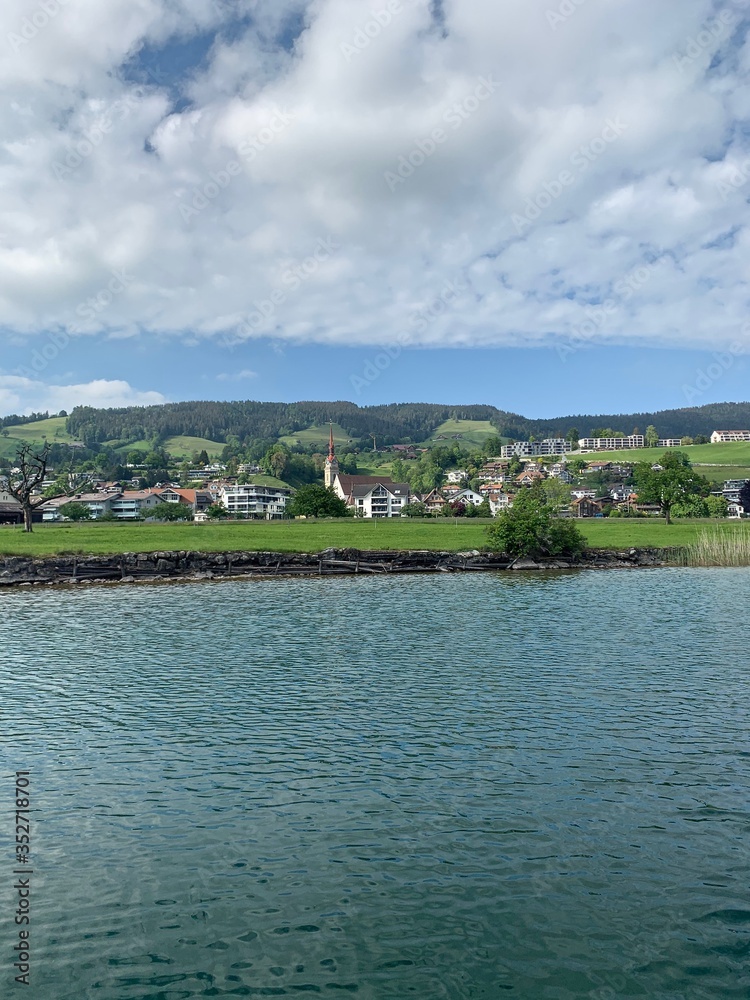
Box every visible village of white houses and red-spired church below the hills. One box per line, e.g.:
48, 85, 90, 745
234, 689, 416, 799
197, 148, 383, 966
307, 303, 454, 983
0, 430, 750, 524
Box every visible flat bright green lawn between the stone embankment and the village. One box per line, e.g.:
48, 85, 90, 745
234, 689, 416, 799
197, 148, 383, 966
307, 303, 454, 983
0, 518, 750, 556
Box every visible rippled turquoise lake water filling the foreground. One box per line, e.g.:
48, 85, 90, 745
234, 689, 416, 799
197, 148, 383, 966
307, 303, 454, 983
0, 569, 750, 1000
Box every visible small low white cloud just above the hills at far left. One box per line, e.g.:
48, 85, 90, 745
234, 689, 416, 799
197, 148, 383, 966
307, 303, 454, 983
0, 375, 167, 414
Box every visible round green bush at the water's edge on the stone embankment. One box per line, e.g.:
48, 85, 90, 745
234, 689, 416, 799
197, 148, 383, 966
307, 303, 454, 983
487, 487, 586, 558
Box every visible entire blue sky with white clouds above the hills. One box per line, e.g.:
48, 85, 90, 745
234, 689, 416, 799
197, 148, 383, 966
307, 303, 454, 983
0, 0, 750, 417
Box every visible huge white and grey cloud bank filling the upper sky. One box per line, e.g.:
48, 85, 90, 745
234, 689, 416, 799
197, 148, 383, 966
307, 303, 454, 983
0, 0, 750, 356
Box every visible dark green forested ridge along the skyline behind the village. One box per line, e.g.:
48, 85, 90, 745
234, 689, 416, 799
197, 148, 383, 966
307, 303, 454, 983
67, 400, 750, 445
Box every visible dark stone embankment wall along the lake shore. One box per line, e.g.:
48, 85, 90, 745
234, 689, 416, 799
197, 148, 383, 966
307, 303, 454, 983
0, 549, 665, 587
